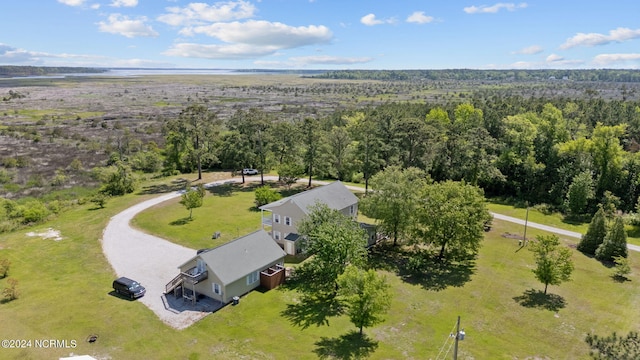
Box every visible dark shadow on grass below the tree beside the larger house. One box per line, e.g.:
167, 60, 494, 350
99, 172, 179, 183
282, 296, 342, 329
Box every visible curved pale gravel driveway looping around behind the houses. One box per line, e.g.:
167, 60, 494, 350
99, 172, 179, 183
102, 176, 640, 329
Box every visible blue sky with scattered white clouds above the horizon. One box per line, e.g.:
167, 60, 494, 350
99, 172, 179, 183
0, 0, 640, 69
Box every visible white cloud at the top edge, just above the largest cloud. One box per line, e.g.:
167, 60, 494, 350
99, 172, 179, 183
157, 0, 256, 26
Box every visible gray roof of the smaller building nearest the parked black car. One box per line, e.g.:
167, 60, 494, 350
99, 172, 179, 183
198, 230, 286, 285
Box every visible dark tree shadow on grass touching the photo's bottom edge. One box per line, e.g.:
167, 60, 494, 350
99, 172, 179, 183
313, 331, 378, 359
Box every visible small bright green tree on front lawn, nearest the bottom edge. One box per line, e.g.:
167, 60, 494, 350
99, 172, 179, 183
338, 265, 391, 335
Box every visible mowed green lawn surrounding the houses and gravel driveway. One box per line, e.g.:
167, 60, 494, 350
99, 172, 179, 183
0, 173, 640, 359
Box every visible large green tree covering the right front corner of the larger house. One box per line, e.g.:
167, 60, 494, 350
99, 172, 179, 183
293, 203, 367, 297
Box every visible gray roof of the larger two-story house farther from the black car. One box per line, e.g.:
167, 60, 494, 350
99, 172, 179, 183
260, 181, 358, 215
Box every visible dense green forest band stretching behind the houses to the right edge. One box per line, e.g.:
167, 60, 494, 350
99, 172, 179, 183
165, 93, 640, 215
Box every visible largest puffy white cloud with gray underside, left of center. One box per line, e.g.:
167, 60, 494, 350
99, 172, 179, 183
188, 20, 333, 49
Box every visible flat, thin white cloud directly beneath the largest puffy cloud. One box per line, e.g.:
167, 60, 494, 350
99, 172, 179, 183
163, 43, 278, 60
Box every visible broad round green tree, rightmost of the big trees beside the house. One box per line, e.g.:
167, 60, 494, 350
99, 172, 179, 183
413, 181, 491, 260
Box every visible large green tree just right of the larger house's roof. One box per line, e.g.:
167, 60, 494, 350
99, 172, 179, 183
360, 166, 426, 246
